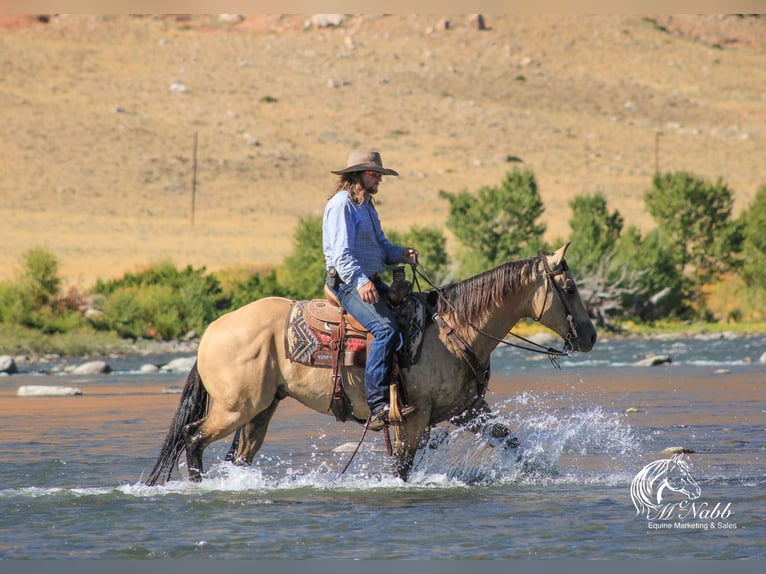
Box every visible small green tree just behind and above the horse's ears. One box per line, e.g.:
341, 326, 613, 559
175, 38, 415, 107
567, 192, 623, 276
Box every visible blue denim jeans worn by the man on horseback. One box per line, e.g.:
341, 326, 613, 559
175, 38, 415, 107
335, 279, 399, 413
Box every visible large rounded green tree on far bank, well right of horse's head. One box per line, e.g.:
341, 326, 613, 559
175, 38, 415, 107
644, 172, 742, 289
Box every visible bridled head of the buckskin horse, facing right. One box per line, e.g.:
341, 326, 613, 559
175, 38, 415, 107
533, 243, 597, 352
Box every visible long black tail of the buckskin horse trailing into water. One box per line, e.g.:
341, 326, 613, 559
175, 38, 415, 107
144, 361, 207, 486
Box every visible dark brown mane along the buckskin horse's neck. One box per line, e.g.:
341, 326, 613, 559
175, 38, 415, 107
436, 256, 540, 324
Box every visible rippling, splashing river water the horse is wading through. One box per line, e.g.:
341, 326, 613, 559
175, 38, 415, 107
0, 337, 766, 559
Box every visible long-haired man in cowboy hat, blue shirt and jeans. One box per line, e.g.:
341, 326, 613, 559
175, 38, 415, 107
322, 150, 418, 429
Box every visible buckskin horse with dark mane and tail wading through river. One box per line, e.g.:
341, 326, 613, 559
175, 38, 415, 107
145, 243, 597, 485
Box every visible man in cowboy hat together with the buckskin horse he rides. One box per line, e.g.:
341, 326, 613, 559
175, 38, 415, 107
146, 146, 597, 485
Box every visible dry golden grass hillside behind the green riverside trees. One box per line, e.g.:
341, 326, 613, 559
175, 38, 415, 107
0, 15, 766, 285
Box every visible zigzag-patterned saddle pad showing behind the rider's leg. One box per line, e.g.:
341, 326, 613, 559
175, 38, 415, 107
285, 301, 367, 368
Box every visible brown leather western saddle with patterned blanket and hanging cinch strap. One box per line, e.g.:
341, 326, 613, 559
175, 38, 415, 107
285, 287, 426, 422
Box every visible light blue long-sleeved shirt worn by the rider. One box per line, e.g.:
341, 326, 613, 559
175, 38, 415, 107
322, 189, 404, 288
